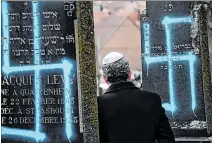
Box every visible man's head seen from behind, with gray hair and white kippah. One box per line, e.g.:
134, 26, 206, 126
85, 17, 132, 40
102, 52, 131, 84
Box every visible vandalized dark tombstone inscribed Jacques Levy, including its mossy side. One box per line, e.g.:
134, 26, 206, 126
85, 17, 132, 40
1, 1, 99, 143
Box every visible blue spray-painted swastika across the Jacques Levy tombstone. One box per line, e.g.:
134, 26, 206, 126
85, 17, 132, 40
2, 1, 74, 142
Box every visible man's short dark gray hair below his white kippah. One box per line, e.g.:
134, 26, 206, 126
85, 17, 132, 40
102, 57, 130, 84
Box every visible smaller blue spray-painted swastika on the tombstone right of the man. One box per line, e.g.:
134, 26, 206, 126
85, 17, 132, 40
143, 16, 196, 114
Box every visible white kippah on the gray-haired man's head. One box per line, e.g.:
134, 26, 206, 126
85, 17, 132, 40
102, 52, 124, 65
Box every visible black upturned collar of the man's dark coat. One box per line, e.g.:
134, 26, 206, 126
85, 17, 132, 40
105, 81, 138, 93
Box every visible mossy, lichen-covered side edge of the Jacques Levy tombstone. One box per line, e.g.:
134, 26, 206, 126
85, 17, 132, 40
77, 1, 99, 143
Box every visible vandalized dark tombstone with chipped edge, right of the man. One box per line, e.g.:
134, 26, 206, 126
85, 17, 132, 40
141, 1, 212, 137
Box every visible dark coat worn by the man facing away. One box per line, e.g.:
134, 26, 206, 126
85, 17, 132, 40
98, 82, 175, 143
